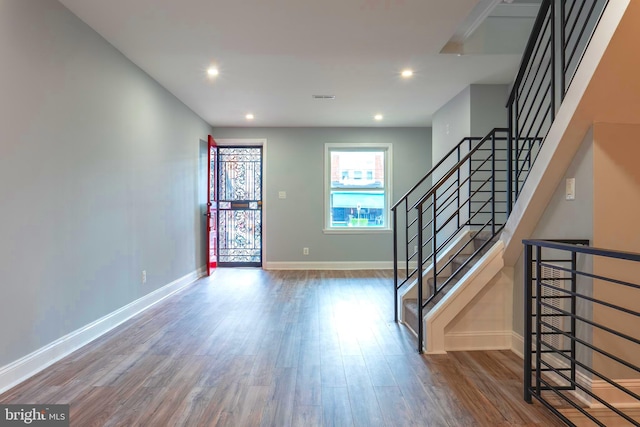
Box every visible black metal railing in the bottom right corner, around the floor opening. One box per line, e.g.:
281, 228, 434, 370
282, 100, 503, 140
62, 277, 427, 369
523, 240, 640, 426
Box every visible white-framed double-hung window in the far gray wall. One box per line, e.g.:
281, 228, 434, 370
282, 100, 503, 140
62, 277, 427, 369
325, 144, 391, 233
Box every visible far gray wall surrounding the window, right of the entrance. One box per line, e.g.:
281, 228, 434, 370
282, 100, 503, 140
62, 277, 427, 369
214, 128, 431, 263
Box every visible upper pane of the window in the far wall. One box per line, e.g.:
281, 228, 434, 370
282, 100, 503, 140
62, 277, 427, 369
331, 150, 384, 188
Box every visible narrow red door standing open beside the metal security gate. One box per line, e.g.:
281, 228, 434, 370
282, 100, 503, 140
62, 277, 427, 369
207, 135, 218, 276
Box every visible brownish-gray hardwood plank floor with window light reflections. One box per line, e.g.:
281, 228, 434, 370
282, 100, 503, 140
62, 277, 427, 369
0, 269, 562, 427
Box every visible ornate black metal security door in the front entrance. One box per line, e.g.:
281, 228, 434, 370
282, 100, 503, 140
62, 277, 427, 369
218, 146, 262, 267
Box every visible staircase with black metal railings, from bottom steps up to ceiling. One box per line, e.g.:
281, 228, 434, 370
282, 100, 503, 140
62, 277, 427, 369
392, 0, 607, 352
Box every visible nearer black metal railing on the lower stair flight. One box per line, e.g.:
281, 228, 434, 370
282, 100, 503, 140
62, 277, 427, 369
412, 129, 508, 352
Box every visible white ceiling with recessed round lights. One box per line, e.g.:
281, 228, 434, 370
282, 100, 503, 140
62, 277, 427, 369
60, 0, 528, 127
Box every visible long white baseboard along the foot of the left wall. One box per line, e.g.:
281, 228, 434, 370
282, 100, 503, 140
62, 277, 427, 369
0, 268, 206, 393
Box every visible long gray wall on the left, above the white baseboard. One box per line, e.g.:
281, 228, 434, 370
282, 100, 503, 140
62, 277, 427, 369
0, 0, 210, 366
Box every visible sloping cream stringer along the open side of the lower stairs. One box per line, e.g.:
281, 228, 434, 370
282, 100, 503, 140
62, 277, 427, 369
423, 241, 504, 354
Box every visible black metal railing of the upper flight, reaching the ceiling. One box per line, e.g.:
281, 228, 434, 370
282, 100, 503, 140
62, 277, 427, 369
507, 0, 608, 211
